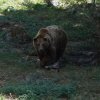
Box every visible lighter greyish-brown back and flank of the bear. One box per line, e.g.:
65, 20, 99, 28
46, 25, 67, 60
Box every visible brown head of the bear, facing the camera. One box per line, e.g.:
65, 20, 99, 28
33, 28, 51, 55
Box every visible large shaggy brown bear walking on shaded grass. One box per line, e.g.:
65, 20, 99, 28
33, 25, 67, 68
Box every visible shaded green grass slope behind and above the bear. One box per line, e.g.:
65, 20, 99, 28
0, 0, 95, 41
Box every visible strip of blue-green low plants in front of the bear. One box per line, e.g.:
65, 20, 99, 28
0, 80, 76, 100
